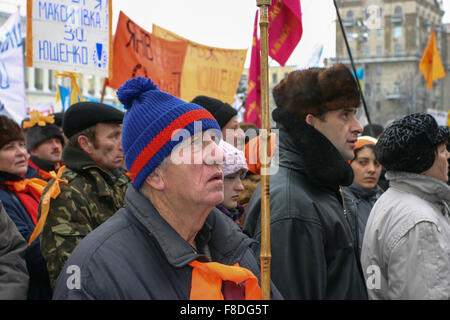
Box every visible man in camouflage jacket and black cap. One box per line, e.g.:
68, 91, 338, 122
40, 102, 129, 287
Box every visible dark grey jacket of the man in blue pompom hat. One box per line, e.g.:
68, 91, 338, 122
53, 185, 280, 300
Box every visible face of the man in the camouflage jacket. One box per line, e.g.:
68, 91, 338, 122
90, 123, 123, 170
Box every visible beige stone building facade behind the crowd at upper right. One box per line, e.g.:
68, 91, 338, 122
333, 0, 450, 125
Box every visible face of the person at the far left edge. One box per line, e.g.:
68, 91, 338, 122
0, 140, 30, 177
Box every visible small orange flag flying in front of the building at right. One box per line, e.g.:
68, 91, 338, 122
419, 30, 445, 90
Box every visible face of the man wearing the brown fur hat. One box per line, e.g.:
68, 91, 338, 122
313, 108, 363, 160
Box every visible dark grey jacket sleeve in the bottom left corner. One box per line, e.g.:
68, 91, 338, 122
0, 201, 29, 300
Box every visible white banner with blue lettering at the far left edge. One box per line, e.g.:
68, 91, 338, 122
0, 11, 27, 124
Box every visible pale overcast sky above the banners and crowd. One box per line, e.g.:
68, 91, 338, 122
0, 0, 450, 67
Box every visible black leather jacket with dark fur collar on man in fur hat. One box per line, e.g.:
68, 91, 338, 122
244, 108, 367, 299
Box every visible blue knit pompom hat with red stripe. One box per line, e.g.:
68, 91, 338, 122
117, 77, 220, 189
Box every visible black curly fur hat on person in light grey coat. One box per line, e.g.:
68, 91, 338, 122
375, 113, 449, 174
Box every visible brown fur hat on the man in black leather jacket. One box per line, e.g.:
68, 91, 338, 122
272, 64, 361, 119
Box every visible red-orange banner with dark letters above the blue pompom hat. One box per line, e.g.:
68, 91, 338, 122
106, 11, 188, 97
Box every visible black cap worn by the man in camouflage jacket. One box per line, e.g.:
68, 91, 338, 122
63, 101, 124, 138
